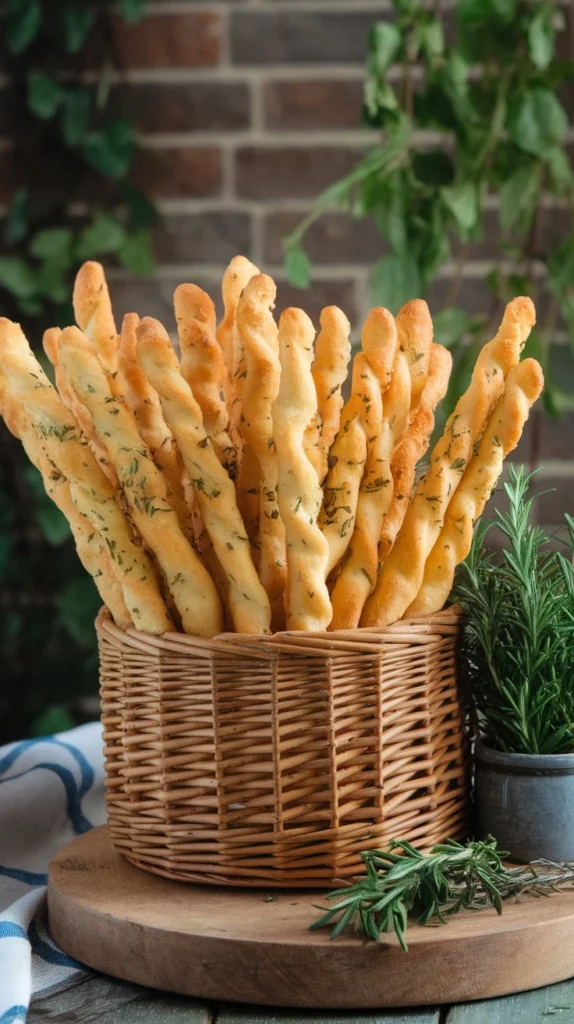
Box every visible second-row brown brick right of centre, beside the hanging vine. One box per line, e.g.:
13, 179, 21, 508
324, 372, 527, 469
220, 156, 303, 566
264, 79, 362, 131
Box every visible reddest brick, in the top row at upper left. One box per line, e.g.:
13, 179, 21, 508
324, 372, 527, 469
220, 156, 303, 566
116, 11, 221, 68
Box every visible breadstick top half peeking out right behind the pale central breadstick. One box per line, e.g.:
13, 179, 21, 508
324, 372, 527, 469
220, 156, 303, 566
305, 306, 351, 483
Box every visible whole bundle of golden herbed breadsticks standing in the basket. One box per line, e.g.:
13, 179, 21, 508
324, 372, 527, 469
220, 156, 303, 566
0, 256, 543, 637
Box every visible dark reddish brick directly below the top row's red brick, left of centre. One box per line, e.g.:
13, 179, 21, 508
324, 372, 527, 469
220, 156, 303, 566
127, 82, 250, 132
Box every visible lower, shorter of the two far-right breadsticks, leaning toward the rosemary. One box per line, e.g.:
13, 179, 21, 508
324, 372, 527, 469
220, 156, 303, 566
406, 359, 544, 617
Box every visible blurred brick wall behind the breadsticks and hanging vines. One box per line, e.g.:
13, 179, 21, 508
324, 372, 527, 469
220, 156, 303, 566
107, 0, 574, 522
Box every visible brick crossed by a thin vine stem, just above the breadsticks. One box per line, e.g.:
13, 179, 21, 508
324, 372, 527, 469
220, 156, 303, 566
264, 210, 389, 264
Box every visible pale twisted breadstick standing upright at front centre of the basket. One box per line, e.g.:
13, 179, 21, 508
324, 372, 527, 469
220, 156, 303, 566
272, 309, 332, 630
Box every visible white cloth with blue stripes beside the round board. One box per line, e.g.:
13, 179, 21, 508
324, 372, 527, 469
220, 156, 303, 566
0, 723, 105, 1024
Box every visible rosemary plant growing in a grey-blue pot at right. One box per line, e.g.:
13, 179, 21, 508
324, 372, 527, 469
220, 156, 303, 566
453, 467, 574, 861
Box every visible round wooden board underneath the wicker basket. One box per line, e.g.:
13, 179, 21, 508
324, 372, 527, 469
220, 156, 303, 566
48, 827, 574, 1010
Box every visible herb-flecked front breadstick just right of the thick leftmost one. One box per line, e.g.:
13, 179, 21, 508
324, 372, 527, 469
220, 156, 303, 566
59, 328, 222, 637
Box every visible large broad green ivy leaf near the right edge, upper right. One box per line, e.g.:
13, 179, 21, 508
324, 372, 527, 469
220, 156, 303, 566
506, 86, 568, 158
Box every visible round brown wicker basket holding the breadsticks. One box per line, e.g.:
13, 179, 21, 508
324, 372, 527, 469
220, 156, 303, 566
97, 609, 468, 888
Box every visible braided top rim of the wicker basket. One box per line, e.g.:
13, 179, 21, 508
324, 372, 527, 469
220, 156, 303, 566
96, 604, 462, 657
